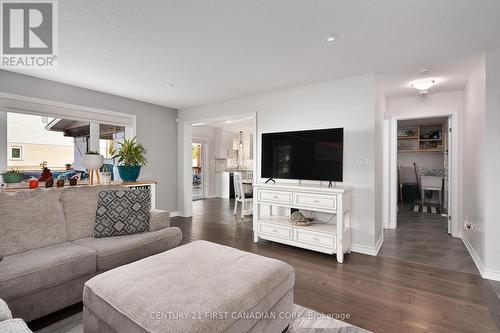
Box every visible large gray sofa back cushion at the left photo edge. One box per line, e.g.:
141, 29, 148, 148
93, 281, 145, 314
0, 189, 67, 255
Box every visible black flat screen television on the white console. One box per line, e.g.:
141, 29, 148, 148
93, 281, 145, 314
261, 128, 344, 182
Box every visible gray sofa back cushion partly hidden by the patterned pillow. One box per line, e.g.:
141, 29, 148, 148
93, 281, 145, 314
61, 185, 122, 241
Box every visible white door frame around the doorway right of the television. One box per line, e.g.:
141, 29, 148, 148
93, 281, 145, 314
384, 111, 462, 238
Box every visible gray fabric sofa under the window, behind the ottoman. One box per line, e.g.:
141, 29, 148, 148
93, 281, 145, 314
0, 186, 182, 321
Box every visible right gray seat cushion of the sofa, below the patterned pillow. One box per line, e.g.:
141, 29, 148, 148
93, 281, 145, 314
73, 227, 182, 271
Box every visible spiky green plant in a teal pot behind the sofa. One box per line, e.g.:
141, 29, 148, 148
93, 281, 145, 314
113, 138, 147, 182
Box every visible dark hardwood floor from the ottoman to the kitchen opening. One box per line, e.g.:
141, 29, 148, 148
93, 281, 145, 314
172, 199, 498, 333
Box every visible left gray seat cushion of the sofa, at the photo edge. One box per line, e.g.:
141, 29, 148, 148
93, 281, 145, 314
0, 242, 96, 301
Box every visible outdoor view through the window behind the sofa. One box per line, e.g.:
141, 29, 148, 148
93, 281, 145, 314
7, 113, 125, 176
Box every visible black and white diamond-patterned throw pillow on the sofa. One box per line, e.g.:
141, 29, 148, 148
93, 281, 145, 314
94, 189, 151, 238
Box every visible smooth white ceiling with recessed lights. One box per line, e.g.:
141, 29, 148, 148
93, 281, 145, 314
9, 0, 500, 108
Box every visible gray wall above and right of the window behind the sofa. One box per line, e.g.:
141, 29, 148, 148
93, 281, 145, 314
0, 70, 177, 211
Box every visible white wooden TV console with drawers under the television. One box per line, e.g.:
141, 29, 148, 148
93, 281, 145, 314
253, 183, 352, 263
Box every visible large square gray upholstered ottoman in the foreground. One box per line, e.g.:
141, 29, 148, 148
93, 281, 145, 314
83, 241, 295, 333
